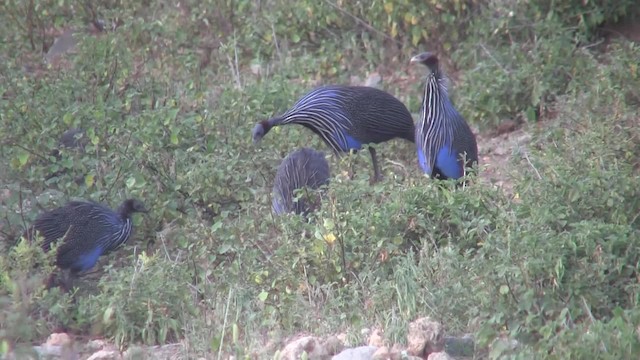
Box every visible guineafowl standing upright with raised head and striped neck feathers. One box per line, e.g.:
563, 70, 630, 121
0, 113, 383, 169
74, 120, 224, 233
411, 52, 478, 179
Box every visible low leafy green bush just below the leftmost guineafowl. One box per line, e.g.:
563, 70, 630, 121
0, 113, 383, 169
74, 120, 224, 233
77, 253, 196, 346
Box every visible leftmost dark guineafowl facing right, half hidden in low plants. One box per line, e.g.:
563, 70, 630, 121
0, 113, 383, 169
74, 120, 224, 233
25, 199, 147, 274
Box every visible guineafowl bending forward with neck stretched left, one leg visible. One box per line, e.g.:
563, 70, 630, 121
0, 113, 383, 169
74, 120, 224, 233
253, 85, 415, 181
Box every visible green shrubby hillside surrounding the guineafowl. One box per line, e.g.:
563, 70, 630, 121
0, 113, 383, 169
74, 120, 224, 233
0, 0, 640, 359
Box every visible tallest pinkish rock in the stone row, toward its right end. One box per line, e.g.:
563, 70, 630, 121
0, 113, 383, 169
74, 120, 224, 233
407, 317, 444, 357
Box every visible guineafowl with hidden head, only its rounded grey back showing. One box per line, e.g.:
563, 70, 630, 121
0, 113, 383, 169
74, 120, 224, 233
272, 148, 330, 215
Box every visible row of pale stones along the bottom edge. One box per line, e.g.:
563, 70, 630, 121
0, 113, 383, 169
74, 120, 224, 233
12, 318, 484, 360
